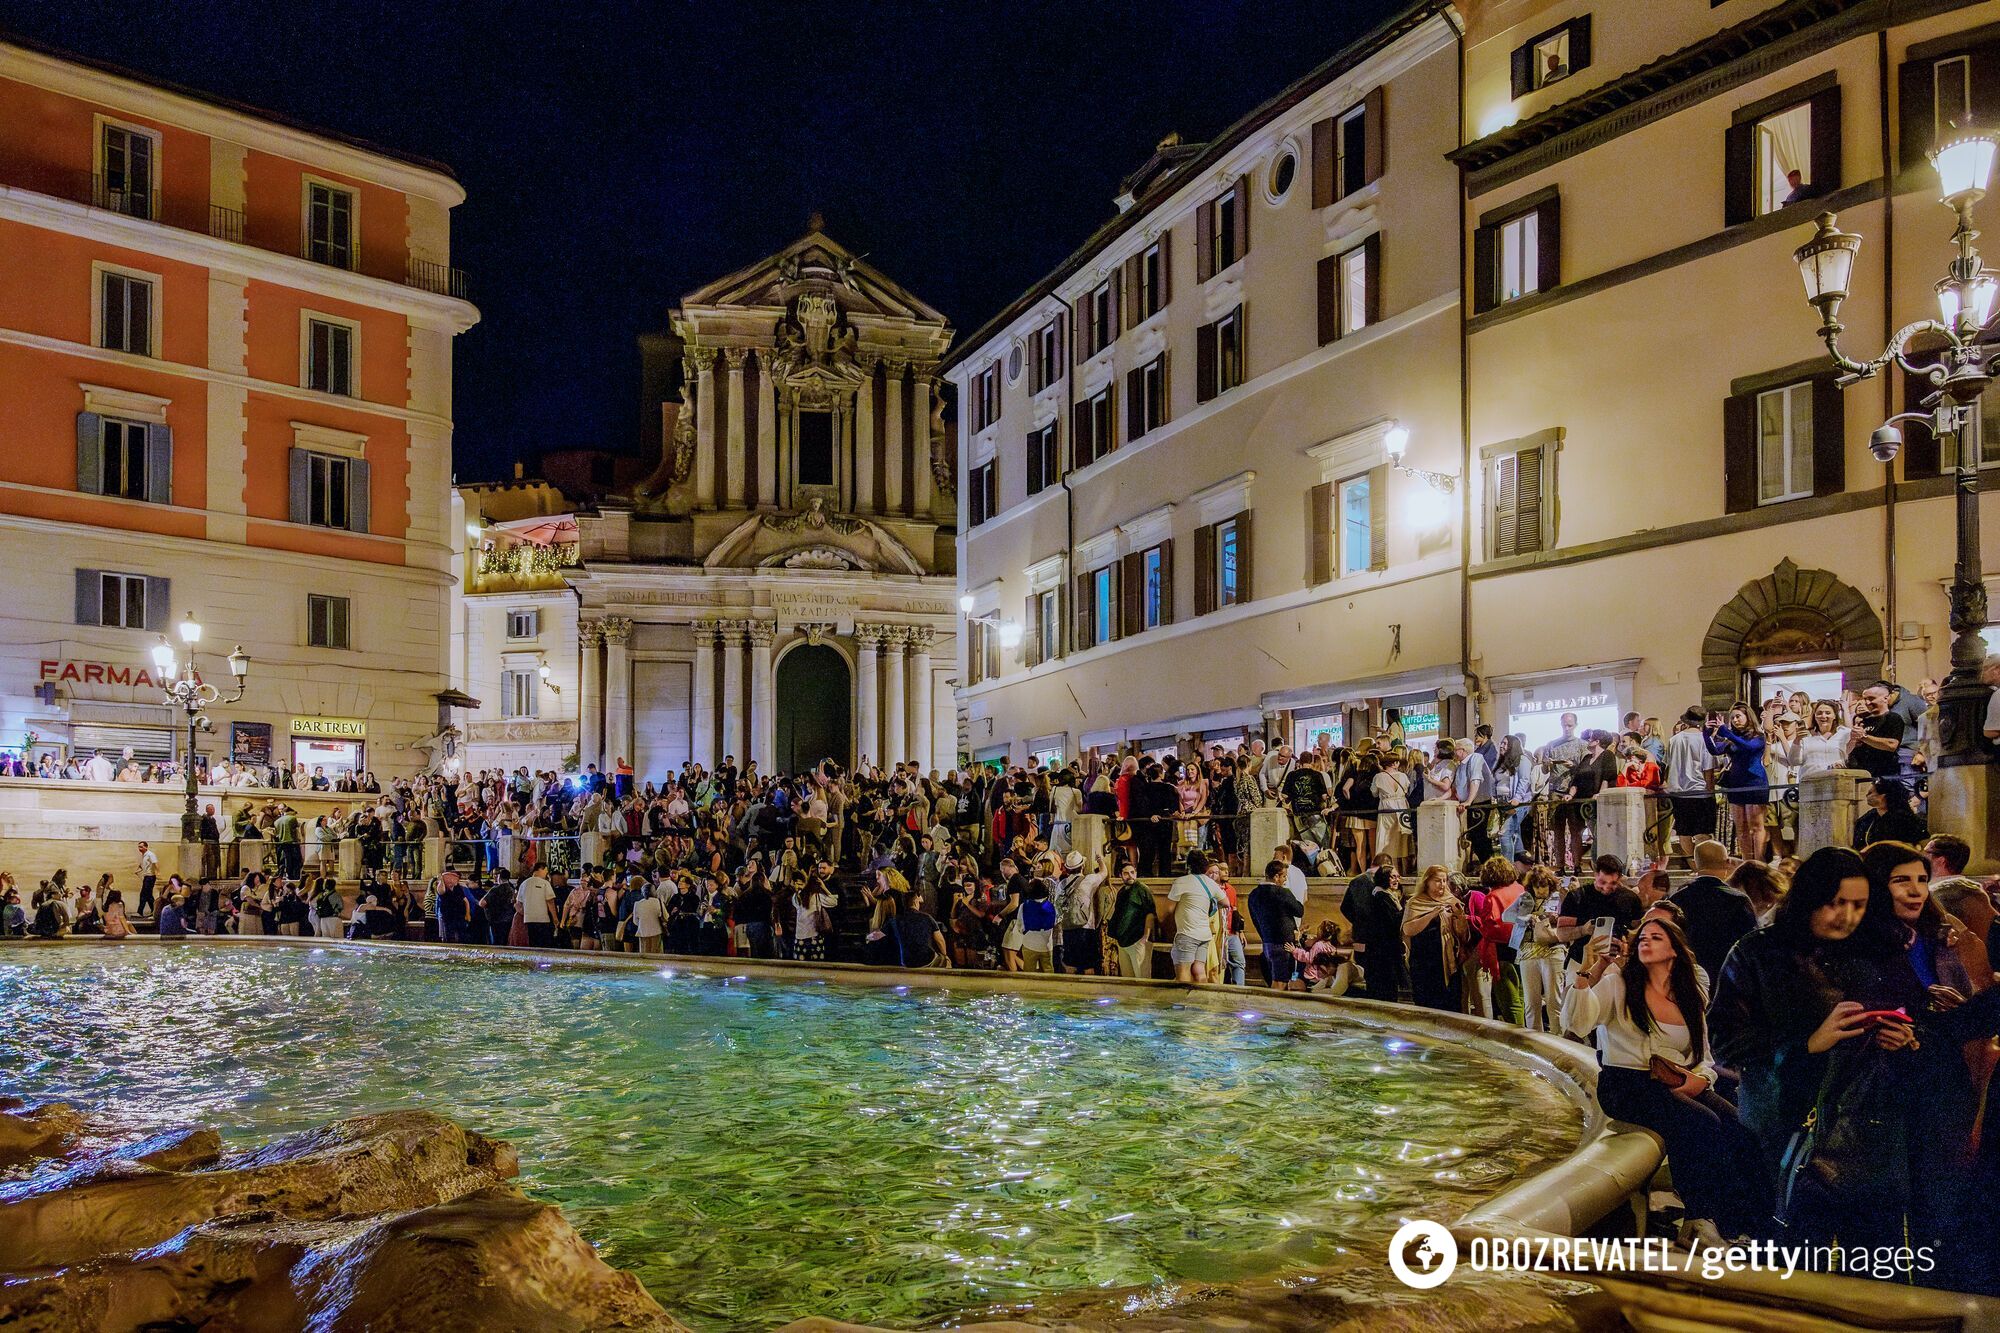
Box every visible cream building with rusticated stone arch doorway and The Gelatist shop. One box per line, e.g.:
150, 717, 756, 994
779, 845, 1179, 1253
1454, 0, 2000, 731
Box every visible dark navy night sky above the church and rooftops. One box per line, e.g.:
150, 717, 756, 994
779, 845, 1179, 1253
0, 0, 1400, 480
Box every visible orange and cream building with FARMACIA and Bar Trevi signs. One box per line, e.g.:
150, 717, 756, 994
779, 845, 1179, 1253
0, 38, 478, 775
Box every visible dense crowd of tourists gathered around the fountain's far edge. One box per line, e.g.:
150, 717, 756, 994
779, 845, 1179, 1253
11, 685, 2000, 1291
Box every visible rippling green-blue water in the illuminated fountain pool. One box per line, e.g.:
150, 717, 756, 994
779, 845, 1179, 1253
0, 945, 1578, 1329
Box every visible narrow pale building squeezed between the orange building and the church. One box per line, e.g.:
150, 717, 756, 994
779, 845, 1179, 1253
452, 480, 582, 773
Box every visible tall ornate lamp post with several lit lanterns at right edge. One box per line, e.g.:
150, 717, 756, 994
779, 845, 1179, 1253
1792, 128, 2000, 772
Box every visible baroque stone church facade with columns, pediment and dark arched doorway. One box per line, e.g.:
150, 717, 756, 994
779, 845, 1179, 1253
566, 224, 958, 781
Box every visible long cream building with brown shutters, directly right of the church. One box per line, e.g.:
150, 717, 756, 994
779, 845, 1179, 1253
948, 6, 1468, 761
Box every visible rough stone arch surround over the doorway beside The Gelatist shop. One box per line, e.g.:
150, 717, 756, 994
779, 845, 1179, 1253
1702, 558, 1886, 709
